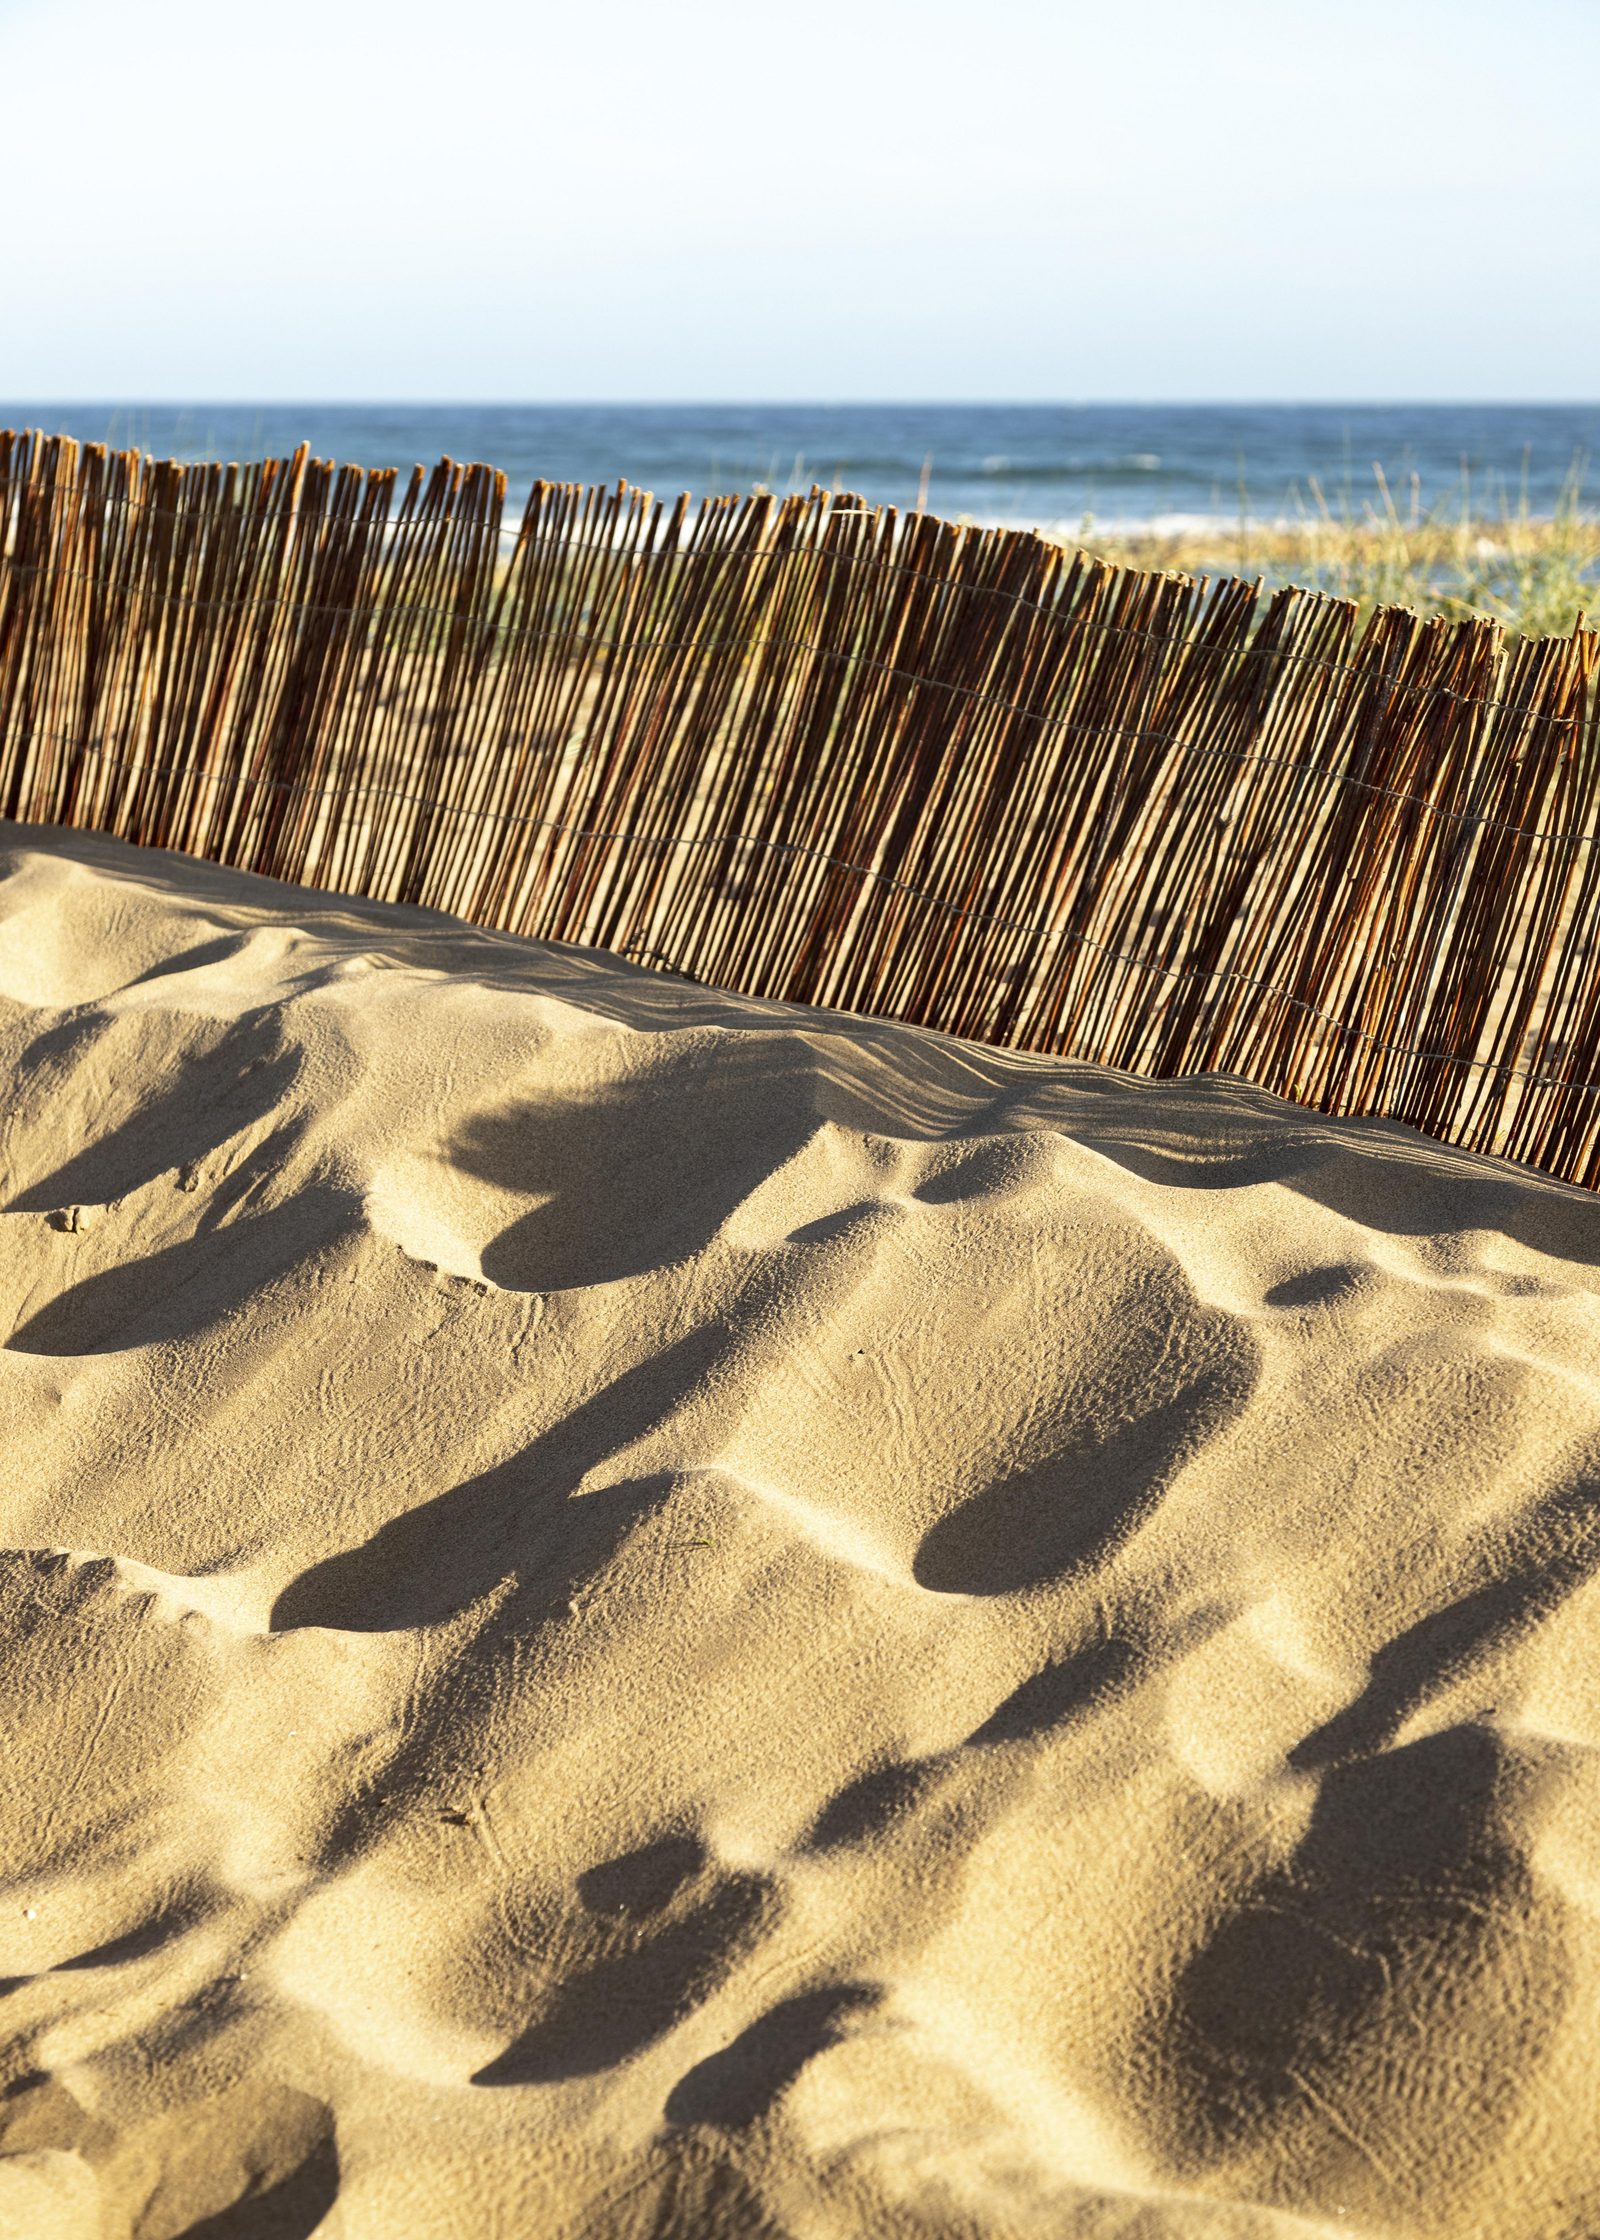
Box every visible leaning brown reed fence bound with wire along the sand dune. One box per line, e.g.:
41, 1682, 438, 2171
0, 435, 1600, 1185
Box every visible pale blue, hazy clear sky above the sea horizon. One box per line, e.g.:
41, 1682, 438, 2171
0, 0, 1600, 401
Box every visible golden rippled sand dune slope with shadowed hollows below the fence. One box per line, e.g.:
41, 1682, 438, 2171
0, 831, 1600, 2240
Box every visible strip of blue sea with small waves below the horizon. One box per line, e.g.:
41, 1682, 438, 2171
0, 399, 1600, 529
